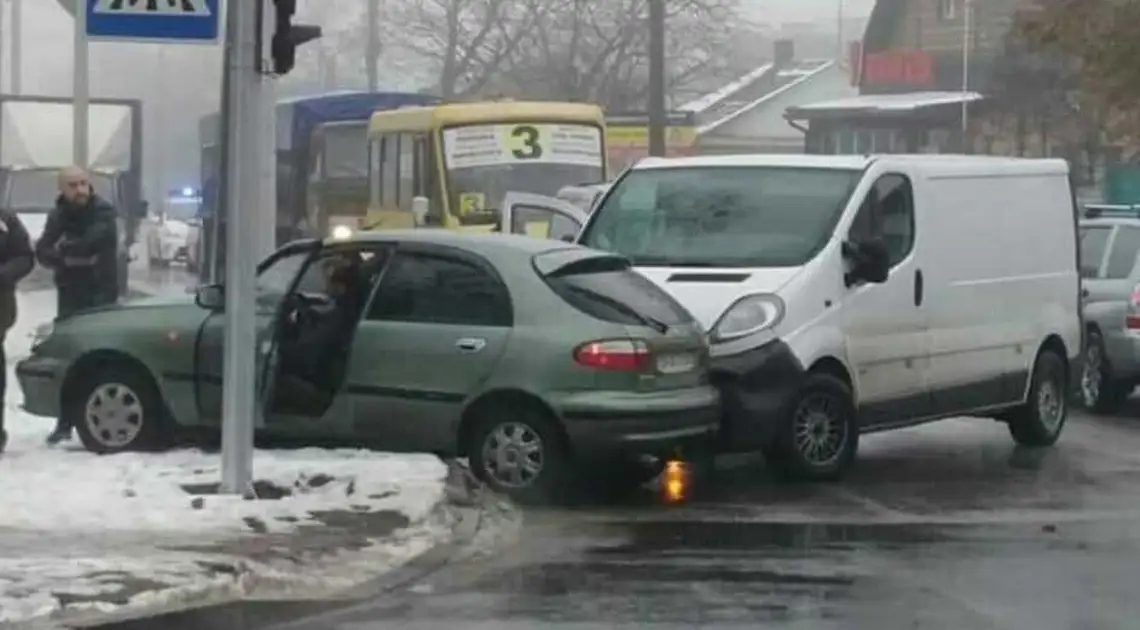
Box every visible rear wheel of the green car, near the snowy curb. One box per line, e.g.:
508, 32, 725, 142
466, 404, 572, 502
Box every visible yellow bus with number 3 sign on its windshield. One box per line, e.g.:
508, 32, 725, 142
361, 101, 605, 231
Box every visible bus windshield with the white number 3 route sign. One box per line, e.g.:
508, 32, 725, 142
443, 123, 605, 215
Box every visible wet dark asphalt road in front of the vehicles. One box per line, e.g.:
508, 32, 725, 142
269, 402, 1140, 630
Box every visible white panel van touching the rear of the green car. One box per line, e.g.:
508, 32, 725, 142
503, 155, 1082, 480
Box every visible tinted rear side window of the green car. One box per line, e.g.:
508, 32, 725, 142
367, 252, 512, 326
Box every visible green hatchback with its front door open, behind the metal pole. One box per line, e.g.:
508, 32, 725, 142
16, 230, 719, 498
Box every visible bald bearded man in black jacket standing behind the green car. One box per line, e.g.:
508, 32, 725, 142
35, 166, 119, 444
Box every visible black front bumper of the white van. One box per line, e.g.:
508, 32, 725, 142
711, 339, 805, 452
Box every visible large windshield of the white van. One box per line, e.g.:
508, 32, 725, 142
580, 166, 862, 267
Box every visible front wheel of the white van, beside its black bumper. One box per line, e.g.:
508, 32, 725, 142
764, 373, 858, 482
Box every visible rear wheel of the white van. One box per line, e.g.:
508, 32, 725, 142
1008, 350, 1068, 447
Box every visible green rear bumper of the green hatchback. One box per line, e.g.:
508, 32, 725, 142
561, 386, 720, 459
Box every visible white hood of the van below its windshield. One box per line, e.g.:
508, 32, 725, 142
635, 267, 801, 332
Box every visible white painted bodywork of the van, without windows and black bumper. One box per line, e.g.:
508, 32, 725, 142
600, 155, 1082, 428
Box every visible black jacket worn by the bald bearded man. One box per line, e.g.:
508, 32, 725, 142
35, 195, 119, 305
